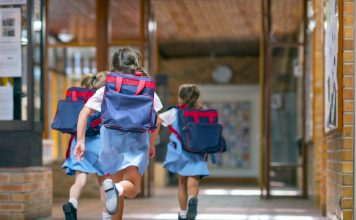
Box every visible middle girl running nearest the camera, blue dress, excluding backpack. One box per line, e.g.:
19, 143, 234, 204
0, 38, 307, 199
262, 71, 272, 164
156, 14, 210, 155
74, 47, 163, 217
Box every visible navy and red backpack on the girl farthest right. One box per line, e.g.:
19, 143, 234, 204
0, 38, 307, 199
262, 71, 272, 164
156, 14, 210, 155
168, 106, 226, 154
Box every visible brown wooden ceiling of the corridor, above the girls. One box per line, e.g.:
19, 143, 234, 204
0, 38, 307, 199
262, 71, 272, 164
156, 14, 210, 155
48, 0, 303, 58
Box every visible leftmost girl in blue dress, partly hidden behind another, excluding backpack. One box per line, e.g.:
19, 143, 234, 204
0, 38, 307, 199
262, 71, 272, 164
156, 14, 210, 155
62, 72, 111, 220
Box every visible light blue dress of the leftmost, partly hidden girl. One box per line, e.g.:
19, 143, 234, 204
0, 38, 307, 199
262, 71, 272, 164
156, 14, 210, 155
62, 135, 104, 176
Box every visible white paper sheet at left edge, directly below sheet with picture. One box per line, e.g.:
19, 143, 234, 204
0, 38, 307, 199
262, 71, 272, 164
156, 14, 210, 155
0, 43, 22, 77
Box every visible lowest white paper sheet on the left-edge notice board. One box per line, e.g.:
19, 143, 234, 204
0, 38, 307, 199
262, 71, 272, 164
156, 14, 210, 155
0, 83, 14, 120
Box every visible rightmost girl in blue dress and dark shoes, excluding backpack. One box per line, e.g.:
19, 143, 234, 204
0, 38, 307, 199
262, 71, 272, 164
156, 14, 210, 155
159, 84, 209, 220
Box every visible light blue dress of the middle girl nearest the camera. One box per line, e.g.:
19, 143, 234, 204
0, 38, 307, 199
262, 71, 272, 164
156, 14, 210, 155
99, 126, 149, 175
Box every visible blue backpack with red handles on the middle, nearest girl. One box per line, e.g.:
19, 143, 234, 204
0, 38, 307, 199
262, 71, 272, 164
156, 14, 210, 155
101, 72, 157, 132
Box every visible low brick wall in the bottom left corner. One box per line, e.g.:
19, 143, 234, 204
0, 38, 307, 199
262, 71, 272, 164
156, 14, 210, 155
0, 167, 52, 220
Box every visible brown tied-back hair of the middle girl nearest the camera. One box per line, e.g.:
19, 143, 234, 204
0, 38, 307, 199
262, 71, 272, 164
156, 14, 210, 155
110, 47, 148, 75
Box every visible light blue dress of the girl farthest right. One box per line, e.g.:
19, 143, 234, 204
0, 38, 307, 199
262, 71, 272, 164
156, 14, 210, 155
163, 110, 209, 178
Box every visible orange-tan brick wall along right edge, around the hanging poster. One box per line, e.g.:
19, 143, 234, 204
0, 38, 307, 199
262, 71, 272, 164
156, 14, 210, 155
308, 0, 354, 219
